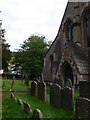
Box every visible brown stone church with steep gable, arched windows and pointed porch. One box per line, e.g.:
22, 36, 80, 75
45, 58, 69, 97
42, 2, 90, 86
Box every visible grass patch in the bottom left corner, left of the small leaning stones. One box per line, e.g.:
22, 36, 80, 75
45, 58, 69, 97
2, 96, 31, 120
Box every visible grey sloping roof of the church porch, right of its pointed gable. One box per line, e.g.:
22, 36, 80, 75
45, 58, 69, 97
67, 42, 90, 74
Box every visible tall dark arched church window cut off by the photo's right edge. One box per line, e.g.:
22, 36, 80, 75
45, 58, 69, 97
85, 10, 90, 47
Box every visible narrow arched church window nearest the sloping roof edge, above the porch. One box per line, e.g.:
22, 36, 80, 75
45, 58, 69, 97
65, 20, 73, 42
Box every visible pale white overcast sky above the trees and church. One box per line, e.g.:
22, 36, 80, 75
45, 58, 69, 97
0, 0, 68, 51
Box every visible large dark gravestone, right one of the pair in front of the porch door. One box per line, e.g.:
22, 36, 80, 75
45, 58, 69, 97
61, 87, 74, 113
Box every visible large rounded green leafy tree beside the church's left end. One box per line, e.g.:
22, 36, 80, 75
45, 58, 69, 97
15, 35, 48, 79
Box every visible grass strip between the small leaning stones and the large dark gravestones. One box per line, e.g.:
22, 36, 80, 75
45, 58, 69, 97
17, 95, 74, 118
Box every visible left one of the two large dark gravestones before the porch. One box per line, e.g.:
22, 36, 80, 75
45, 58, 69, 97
50, 84, 61, 108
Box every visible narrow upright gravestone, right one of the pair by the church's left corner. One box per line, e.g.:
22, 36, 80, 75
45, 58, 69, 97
37, 81, 46, 102
